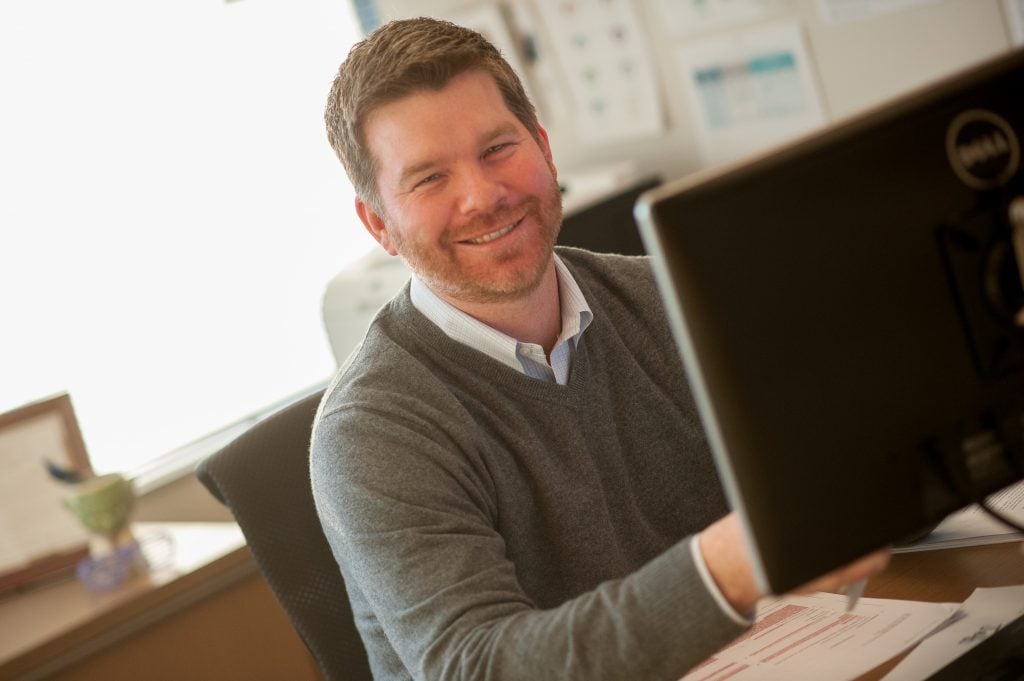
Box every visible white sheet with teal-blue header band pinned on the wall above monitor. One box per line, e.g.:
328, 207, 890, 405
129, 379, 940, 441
677, 23, 825, 166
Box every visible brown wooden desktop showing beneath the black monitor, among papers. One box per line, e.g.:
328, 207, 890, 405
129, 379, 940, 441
861, 542, 1024, 681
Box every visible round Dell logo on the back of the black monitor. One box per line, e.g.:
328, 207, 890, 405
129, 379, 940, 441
946, 109, 1021, 189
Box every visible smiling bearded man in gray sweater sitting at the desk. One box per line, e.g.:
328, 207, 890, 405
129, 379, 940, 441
311, 18, 885, 681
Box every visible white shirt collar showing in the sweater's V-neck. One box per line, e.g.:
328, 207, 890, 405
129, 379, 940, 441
410, 255, 594, 385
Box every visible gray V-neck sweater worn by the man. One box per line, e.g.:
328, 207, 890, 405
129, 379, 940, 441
311, 249, 742, 681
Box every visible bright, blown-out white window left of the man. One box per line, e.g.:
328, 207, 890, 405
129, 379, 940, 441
0, 0, 372, 481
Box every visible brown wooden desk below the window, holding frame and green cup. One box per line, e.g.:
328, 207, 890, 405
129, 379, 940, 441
0, 522, 321, 681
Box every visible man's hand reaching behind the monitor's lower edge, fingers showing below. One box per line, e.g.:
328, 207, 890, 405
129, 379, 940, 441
697, 513, 890, 612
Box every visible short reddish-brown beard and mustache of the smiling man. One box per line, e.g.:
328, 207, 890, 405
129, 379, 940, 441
392, 177, 562, 303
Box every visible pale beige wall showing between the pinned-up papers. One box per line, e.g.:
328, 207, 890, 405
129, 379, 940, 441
370, 0, 1011, 179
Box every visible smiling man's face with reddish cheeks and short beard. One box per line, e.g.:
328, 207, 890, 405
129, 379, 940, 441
356, 71, 562, 303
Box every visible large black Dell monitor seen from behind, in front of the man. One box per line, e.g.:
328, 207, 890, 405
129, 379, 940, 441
636, 51, 1024, 593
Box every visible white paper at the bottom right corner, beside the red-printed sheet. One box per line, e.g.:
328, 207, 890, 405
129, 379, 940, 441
883, 586, 1024, 681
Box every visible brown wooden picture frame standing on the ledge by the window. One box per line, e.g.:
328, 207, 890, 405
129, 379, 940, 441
0, 392, 92, 593
